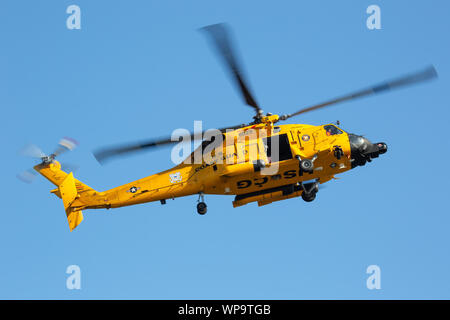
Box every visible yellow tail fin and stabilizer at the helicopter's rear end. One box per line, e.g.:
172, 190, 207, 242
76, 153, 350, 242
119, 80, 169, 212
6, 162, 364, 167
34, 161, 96, 231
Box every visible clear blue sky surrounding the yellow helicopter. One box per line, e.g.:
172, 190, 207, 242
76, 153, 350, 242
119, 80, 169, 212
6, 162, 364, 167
0, 0, 450, 299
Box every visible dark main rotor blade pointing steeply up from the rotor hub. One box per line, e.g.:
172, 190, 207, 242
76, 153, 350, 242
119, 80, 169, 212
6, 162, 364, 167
200, 23, 262, 116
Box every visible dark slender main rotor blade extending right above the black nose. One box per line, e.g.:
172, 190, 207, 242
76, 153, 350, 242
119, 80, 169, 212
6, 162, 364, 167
280, 66, 437, 120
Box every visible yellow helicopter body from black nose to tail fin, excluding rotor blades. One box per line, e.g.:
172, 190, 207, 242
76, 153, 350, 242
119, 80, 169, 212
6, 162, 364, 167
35, 116, 387, 230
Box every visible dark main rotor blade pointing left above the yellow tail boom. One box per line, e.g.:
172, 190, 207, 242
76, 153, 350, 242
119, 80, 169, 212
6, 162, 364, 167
94, 124, 246, 164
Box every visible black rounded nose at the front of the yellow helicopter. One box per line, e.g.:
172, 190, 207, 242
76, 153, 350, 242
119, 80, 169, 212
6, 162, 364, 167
348, 134, 387, 168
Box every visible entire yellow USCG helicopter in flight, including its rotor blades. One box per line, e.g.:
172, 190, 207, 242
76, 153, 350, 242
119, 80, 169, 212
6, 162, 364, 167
23, 23, 437, 231
